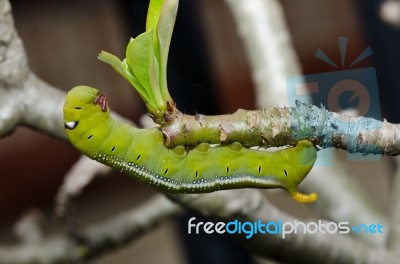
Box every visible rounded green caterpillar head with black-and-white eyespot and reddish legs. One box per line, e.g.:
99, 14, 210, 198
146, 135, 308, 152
64, 86, 109, 139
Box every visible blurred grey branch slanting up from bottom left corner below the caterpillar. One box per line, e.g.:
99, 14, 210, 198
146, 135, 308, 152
0, 195, 182, 264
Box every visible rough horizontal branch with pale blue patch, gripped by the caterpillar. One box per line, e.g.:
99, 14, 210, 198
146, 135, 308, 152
161, 95, 400, 156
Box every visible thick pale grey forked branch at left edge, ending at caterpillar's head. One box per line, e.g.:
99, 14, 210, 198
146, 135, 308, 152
0, 0, 66, 139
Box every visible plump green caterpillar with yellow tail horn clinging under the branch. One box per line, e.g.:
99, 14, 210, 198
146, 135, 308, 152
64, 86, 318, 202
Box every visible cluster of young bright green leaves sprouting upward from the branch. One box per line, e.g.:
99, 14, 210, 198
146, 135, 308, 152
99, 0, 179, 119
